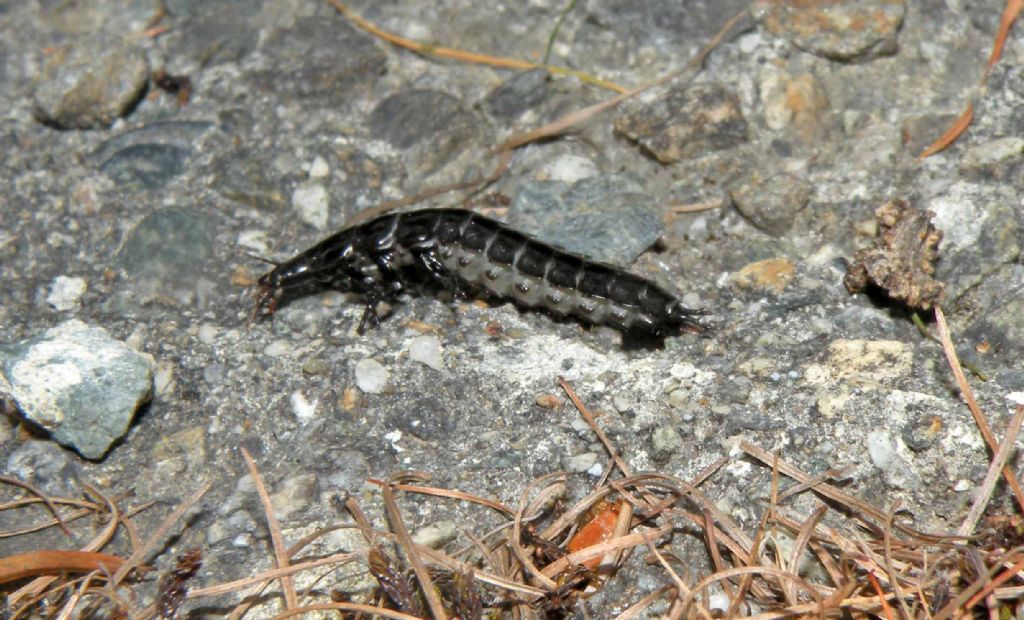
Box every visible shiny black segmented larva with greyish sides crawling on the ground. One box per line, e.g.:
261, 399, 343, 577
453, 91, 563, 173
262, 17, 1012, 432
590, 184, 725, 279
254, 209, 703, 337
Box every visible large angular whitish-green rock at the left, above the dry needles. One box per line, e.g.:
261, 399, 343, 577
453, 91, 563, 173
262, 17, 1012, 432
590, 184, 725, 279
0, 320, 154, 459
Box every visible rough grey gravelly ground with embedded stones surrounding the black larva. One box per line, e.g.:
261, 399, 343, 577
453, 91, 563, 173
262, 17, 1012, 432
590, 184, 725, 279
0, 0, 1024, 617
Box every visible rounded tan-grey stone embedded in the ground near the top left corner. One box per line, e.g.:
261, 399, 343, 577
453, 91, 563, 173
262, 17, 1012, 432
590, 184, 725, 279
33, 36, 150, 129
